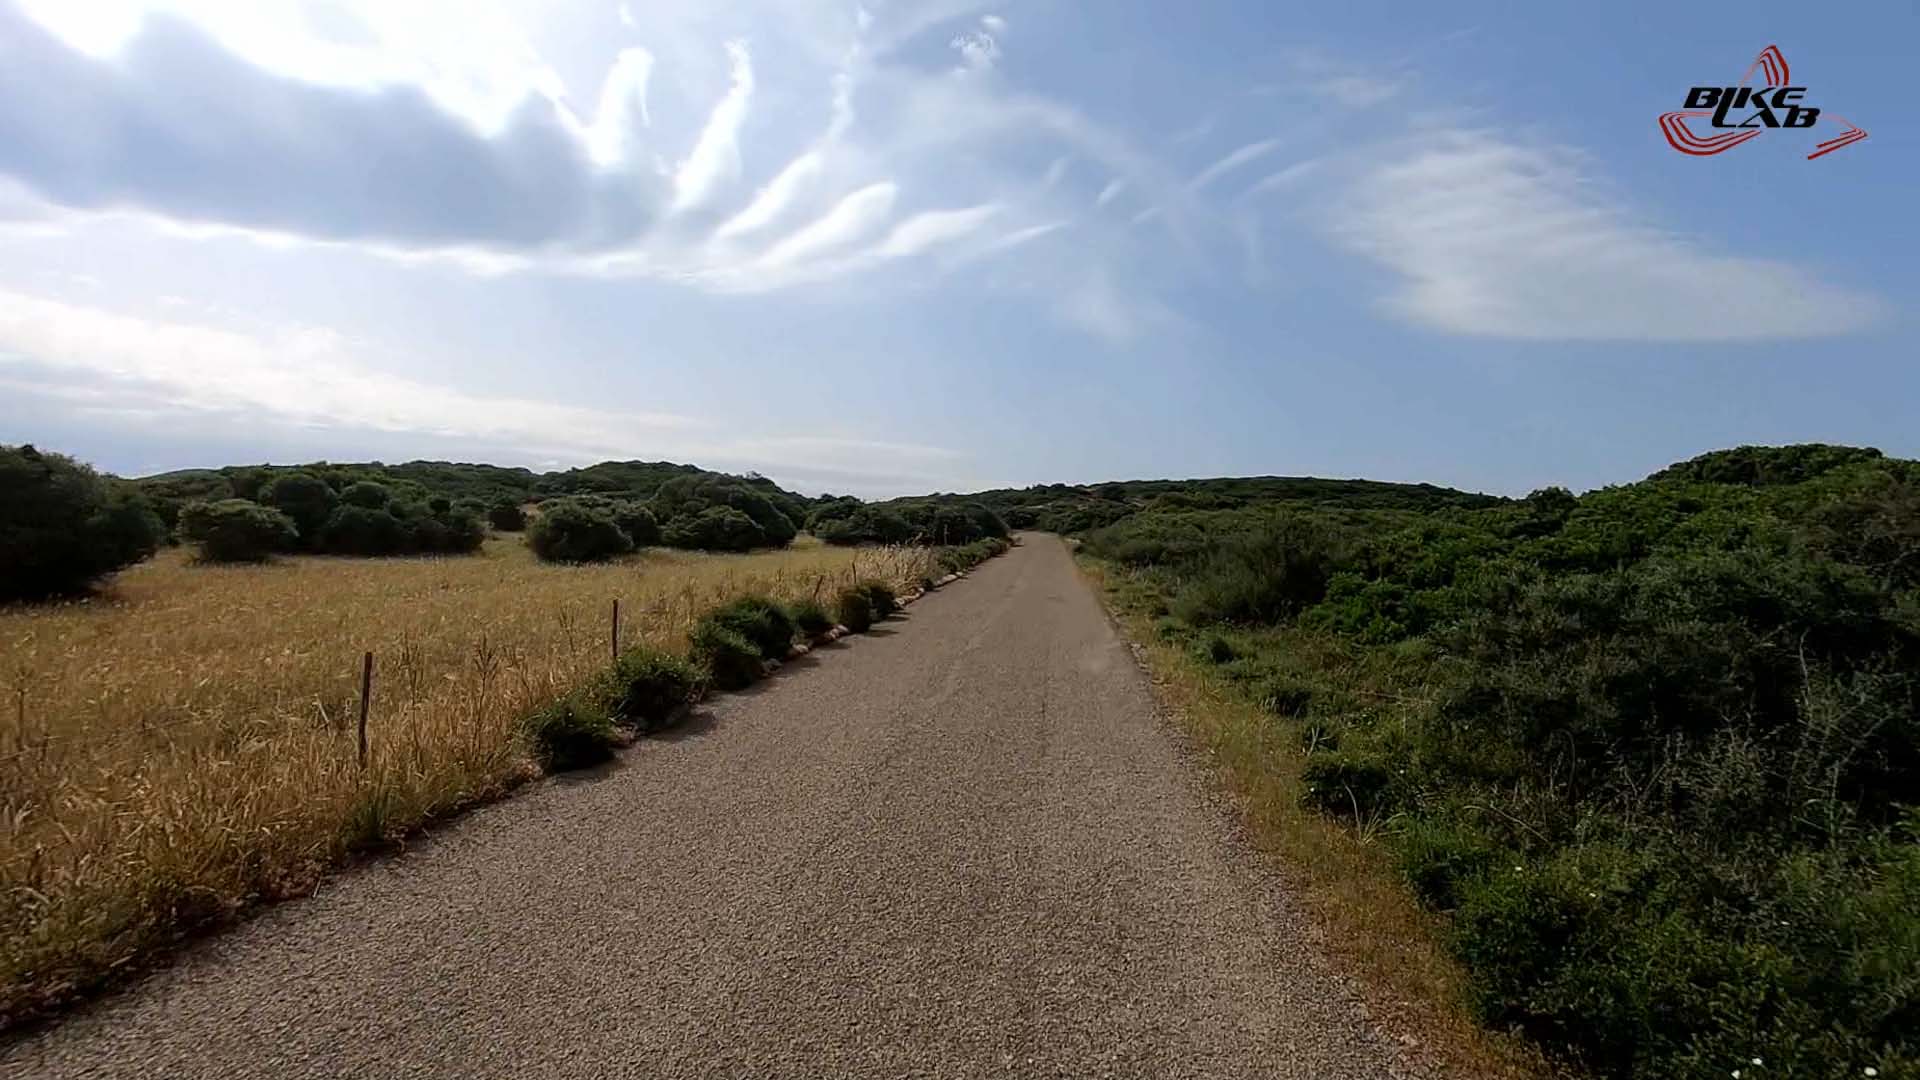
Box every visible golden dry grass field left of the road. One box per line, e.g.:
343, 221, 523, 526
0, 536, 931, 1026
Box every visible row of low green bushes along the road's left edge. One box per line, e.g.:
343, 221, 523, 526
522, 580, 899, 773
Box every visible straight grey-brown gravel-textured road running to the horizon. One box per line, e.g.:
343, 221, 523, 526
0, 536, 1400, 1080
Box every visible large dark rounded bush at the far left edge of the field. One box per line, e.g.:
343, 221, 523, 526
0, 446, 165, 600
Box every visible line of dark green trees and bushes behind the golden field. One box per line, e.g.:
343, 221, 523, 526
0, 446, 1006, 600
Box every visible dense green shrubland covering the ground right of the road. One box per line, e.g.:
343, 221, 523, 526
1082, 446, 1920, 1078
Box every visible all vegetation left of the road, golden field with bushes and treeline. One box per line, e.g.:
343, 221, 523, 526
0, 440, 1004, 1028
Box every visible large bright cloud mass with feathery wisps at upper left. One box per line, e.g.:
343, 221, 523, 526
0, 0, 1274, 343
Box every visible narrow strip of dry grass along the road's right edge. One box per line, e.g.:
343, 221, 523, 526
1081, 559, 1549, 1080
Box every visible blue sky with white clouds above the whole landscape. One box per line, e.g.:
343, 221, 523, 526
0, 0, 1920, 498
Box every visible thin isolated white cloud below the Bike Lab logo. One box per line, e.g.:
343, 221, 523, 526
1329, 131, 1880, 342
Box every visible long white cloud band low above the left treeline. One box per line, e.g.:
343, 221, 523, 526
0, 290, 964, 494
